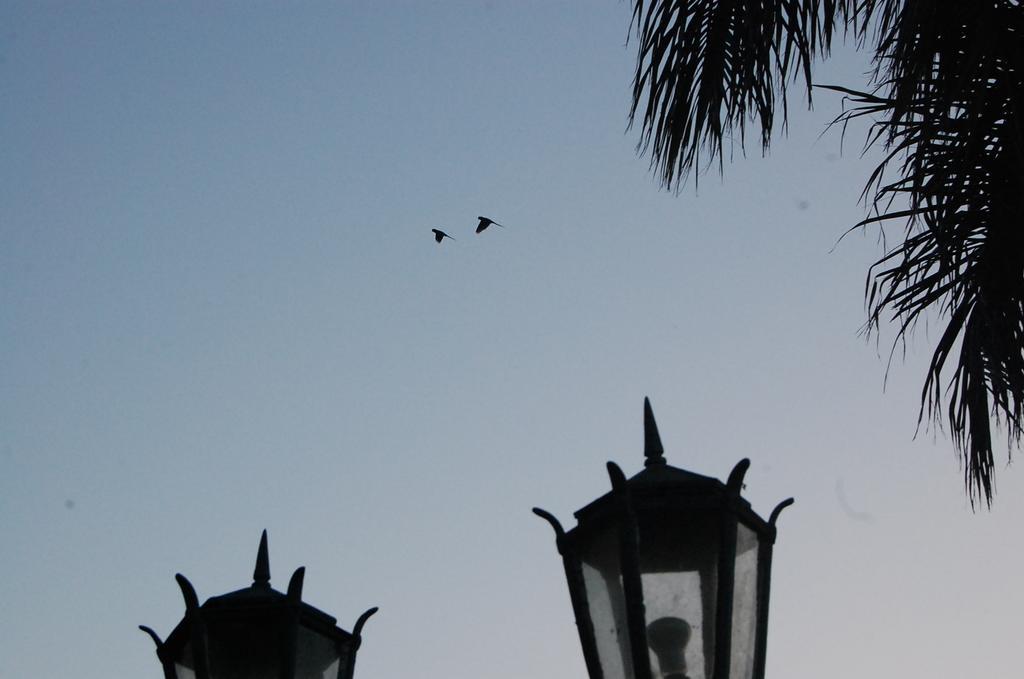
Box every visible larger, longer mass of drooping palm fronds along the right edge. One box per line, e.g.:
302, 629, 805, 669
842, 0, 1024, 506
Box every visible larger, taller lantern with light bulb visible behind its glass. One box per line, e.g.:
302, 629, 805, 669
534, 398, 793, 679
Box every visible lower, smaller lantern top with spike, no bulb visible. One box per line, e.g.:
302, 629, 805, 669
139, 531, 377, 679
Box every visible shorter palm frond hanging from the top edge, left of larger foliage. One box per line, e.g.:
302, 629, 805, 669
630, 0, 855, 187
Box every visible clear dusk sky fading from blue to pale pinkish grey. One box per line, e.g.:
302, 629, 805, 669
0, 0, 1024, 679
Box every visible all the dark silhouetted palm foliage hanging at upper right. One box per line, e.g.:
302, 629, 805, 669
630, 0, 1024, 506
